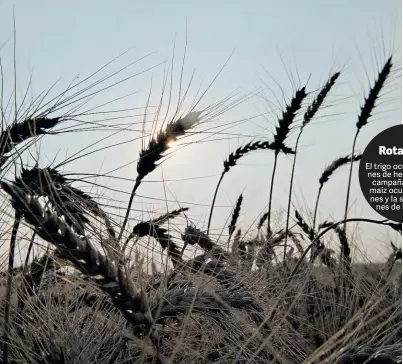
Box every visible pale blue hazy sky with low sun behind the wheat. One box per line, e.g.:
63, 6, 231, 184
0, 0, 402, 259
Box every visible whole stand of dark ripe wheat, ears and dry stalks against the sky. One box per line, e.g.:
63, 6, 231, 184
0, 35, 402, 364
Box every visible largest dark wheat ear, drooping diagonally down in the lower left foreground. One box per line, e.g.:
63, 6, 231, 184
1, 182, 152, 333
